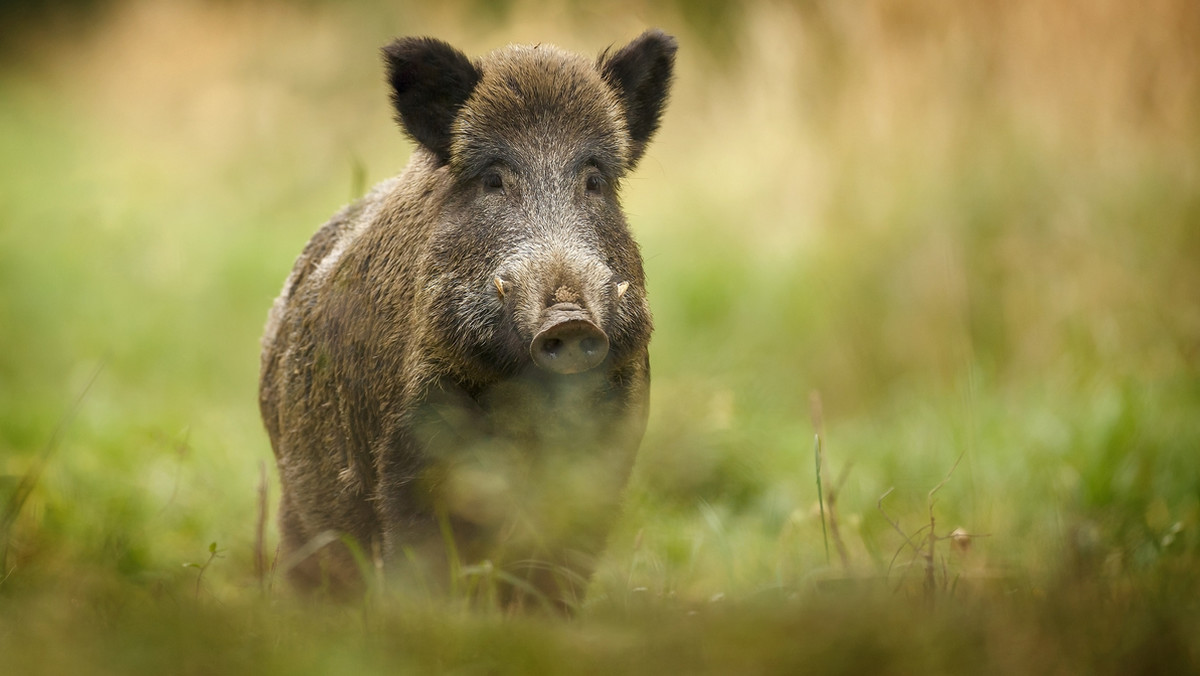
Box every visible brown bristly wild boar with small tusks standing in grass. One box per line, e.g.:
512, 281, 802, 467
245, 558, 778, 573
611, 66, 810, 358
259, 30, 676, 606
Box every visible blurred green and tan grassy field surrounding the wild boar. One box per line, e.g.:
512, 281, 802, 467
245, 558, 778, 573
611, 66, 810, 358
0, 0, 1200, 674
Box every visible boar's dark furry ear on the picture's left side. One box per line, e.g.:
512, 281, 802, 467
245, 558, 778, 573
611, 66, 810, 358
383, 37, 479, 163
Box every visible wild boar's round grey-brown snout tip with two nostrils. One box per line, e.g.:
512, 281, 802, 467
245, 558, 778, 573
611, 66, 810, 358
529, 303, 608, 375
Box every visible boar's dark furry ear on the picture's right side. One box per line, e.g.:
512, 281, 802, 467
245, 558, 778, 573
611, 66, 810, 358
598, 29, 678, 166
